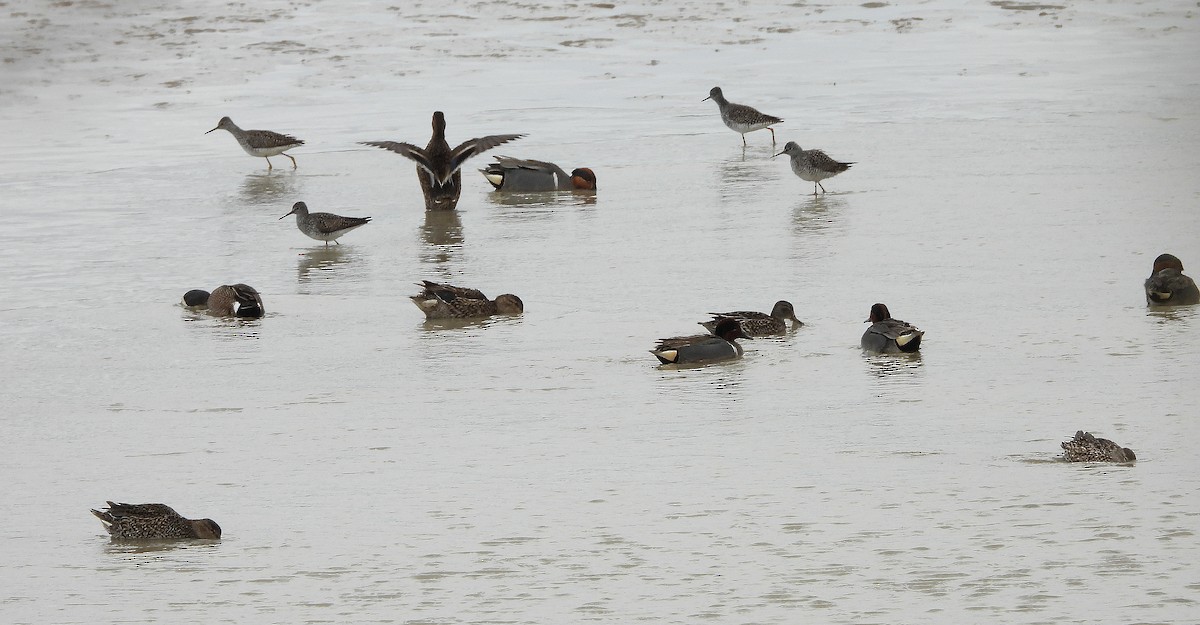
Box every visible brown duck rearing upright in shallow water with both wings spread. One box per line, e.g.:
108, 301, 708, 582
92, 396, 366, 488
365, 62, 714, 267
360, 110, 524, 210
